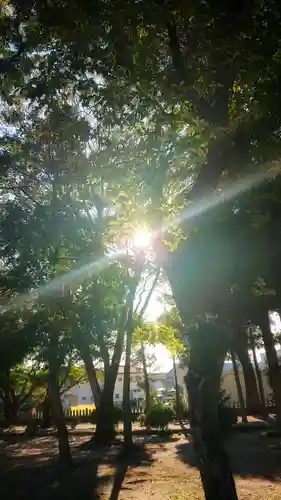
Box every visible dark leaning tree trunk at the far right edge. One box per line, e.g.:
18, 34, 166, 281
258, 311, 281, 428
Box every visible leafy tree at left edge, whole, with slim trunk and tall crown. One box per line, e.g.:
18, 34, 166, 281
1, 96, 101, 469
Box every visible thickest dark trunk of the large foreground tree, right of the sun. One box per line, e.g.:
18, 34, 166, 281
162, 246, 237, 500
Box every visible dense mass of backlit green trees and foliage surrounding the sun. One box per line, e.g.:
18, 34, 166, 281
0, 0, 281, 499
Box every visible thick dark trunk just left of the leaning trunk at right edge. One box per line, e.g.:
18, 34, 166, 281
233, 330, 261, 414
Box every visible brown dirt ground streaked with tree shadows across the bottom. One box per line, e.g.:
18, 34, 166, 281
0, 432, 281, 500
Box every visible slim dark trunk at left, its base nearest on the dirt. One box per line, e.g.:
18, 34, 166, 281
49, 348, 72, 473
